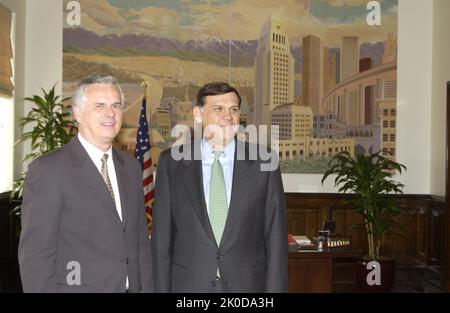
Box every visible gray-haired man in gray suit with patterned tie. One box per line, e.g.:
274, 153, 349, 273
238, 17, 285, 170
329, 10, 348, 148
19, 75, 153, 292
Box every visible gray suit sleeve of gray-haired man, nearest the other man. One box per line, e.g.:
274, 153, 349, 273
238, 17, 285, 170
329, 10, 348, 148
136, 162, 154, 293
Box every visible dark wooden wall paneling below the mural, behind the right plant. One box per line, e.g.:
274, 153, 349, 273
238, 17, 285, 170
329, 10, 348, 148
286, 194, 442, 262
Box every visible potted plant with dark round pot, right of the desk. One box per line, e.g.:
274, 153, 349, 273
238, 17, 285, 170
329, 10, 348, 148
322, 151, 406, 292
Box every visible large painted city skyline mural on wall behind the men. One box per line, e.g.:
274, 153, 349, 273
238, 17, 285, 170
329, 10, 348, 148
63, 0, 398, 173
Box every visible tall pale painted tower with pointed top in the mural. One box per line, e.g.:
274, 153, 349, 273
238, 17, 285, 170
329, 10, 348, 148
253, 17, 294, 125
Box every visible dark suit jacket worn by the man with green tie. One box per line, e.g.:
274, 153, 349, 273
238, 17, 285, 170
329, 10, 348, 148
152, 140, 288, 292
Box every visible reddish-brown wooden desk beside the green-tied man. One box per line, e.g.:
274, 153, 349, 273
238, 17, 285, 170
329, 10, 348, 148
288, 250, 362, 292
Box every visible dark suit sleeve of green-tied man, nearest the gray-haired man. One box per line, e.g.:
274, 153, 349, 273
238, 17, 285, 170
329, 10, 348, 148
152, 154, 173, 292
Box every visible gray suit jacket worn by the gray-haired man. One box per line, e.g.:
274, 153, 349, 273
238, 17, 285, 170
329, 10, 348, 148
19, 137, 153, 292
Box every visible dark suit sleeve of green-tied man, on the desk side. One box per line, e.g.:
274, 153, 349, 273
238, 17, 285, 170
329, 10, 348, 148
264, 152, 288, 292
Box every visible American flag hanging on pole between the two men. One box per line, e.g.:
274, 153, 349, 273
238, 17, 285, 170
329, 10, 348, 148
134, 96, 154, 231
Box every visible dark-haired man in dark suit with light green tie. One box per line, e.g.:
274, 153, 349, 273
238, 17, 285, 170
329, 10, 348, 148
152, 82, 288, 292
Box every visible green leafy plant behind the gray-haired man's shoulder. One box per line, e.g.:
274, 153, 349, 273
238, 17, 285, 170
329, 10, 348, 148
10, 86, 75, 218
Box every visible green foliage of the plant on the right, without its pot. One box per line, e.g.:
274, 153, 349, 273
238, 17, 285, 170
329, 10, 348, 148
322, 151, 406, 259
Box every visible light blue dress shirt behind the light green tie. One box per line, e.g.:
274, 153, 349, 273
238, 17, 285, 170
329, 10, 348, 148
200, 139, 236, 214
